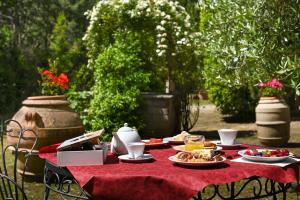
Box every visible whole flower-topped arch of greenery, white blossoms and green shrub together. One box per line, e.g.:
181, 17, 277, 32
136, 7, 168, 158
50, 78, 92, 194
83, 0, 201, 136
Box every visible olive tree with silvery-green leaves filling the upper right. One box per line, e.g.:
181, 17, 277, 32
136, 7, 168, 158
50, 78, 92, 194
199, 0, 300, 114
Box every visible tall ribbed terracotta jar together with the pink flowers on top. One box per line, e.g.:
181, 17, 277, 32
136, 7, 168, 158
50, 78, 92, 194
255, 79, 290, 146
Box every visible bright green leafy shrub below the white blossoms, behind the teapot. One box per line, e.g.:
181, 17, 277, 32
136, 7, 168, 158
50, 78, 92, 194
89, 33, 150, 139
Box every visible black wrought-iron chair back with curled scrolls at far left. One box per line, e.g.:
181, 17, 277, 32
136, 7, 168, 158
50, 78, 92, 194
0, 120, 38, 200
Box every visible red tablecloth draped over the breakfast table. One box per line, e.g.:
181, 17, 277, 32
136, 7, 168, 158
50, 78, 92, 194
40, 145, 299, 200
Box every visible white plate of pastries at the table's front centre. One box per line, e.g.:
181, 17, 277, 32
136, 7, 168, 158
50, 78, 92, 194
169, 149, 226, 167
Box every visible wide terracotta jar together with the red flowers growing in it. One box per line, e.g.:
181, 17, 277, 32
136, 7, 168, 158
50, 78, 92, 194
7, 61, 84, 180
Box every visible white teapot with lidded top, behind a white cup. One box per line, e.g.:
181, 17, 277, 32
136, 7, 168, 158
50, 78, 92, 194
110, 123, 141, 154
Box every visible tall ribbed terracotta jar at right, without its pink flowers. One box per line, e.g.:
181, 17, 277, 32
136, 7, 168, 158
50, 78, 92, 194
255, 97, 290, 146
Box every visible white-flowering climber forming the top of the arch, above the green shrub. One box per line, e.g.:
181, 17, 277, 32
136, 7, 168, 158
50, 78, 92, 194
83, 0, 199, 75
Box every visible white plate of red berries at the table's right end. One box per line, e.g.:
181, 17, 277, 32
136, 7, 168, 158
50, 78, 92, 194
238, 149, 293, 162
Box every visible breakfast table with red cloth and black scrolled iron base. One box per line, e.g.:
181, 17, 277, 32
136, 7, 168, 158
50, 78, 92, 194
39, 143, 299, 200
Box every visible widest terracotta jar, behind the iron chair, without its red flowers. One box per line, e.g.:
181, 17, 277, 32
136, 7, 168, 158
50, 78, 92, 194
7, 95, 84, 180
